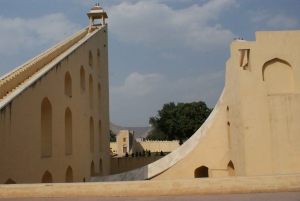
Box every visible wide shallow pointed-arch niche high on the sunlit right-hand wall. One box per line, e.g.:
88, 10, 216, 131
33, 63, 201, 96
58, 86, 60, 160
262, 58, 294, 93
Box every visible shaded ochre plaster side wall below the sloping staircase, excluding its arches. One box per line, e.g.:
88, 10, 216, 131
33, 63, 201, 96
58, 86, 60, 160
0, 26, 110, 183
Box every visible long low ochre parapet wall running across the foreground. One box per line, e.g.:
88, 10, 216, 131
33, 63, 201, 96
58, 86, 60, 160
0, 174, 300, 198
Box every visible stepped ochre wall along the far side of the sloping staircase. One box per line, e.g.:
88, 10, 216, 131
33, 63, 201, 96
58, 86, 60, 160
0, 28, 88, 101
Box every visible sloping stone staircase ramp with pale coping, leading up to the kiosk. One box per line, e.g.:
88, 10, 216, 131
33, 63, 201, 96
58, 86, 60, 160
0, 26, 102, 110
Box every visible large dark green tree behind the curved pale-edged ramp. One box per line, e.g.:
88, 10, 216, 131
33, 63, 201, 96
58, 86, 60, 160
147, 101, 212, 144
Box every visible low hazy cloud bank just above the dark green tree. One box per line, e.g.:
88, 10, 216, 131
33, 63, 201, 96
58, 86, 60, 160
110, 71, 225, 126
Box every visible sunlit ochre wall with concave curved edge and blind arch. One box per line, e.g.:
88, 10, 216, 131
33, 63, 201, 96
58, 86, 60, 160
149, 31, 300, 180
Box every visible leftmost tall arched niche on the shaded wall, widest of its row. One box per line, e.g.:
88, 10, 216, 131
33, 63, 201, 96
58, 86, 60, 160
41, 98, 52, 158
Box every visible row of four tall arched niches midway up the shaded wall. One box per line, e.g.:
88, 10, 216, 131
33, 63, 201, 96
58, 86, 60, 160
41, 97, 102, 158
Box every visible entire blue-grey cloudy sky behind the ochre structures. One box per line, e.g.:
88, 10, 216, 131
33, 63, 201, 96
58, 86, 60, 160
0, 0, 300, 127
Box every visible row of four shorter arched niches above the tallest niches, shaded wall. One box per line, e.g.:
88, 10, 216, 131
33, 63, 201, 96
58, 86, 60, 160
65, 66, 102, 113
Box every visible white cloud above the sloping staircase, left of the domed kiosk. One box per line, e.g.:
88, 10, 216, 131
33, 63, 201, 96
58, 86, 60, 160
0, 13, 79, 55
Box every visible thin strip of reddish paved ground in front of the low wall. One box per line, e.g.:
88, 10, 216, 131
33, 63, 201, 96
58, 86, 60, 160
0, 192, 300, 201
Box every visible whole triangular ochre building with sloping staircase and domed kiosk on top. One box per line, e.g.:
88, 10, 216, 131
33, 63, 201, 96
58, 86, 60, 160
0, 5, 109, 184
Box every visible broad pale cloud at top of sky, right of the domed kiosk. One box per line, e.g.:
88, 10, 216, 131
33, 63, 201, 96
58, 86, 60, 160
107, 0, 235, 51
